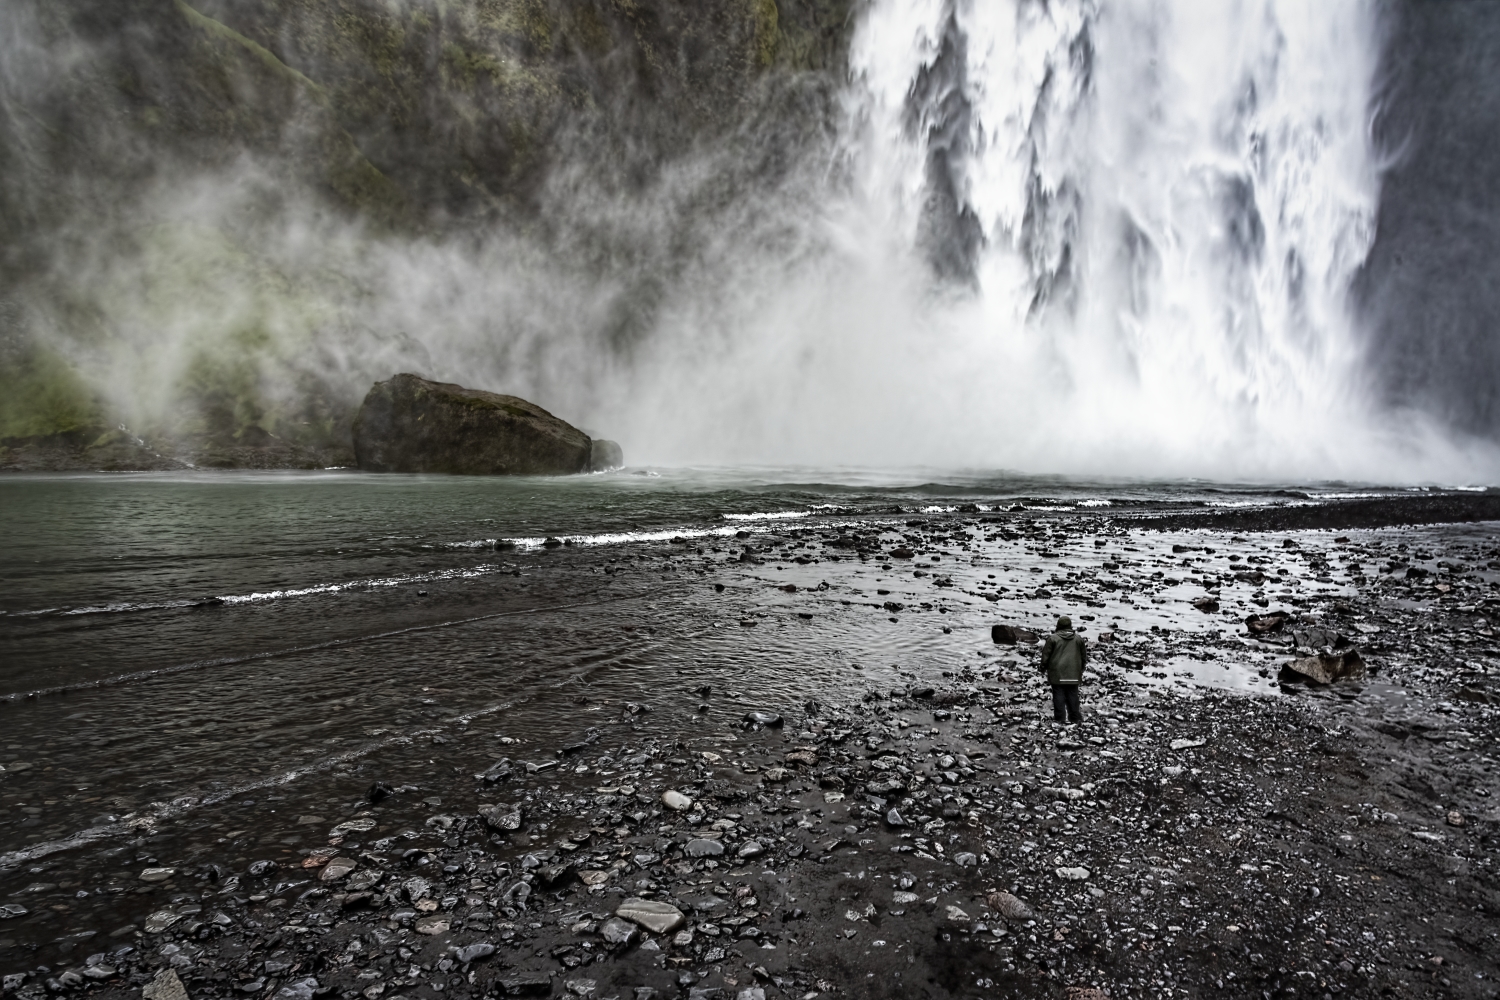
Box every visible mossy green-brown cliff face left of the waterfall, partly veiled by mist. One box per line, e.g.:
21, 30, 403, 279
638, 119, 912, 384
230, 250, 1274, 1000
0, 0, 852, 465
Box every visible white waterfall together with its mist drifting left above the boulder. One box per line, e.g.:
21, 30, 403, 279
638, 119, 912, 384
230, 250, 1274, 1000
8, 0, 1500, 483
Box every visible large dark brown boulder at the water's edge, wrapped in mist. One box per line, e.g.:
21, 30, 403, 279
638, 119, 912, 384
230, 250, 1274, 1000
354, 375, 624, 475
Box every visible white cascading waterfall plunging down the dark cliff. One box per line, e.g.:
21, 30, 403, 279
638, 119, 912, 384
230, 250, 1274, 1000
810, 0, 1404, 475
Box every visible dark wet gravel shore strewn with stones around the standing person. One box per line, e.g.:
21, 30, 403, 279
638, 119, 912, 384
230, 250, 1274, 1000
0, 508, 1500, 1000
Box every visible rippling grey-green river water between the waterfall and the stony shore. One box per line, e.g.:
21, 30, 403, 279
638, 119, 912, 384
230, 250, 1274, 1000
0, 469, 1476, 964
